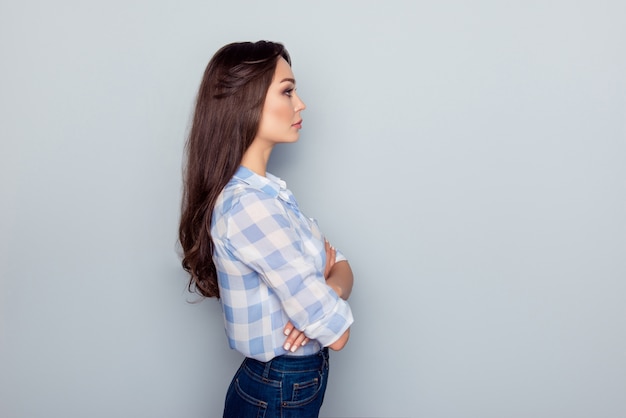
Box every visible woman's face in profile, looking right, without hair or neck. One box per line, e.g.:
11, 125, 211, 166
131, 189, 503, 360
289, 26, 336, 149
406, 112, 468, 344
255, 58, 306, 145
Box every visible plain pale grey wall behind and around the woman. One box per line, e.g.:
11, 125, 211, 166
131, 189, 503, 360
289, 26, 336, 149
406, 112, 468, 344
0, 0, 626, 418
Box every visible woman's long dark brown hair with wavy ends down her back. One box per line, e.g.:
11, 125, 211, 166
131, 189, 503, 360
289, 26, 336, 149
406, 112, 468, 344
178, 41, 291, 298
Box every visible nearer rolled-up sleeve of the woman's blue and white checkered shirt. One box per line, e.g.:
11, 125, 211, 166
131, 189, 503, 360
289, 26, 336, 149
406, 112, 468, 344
225, 189, 354, 346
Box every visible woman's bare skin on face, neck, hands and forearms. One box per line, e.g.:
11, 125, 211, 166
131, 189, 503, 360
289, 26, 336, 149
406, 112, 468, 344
241, 58, 353, 352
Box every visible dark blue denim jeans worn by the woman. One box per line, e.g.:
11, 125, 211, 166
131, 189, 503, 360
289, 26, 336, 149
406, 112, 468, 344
224, 348, 328, 418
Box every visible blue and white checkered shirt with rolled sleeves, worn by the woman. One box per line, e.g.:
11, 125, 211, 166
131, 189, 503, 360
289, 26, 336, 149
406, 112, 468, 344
211, 167, 354, 361
